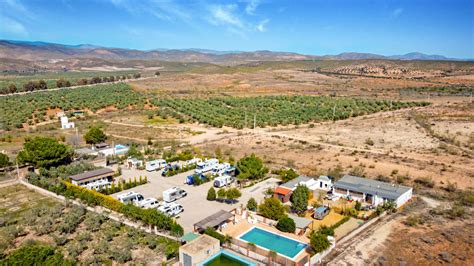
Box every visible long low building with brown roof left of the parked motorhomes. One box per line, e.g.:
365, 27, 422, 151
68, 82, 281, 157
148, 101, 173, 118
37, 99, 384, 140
69, 168, 115, 190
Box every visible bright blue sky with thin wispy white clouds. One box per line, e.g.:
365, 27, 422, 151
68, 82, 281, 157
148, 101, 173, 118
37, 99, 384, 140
0, 0, 474, 58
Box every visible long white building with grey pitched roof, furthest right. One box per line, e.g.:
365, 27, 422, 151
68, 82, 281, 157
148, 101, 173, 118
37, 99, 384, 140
332, 175, 413, 207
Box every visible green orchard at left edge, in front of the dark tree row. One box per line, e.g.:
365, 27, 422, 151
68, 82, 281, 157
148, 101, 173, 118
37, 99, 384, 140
0, 83, 145, 129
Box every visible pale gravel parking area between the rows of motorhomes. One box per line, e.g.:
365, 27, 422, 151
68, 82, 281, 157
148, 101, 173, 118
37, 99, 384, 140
112, 169, 279, 232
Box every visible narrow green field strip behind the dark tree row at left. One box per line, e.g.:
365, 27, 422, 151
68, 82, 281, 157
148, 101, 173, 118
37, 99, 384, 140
0, 70, 139, 92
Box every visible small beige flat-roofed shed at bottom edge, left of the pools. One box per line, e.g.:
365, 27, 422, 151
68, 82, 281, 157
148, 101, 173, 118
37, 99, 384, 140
179, 235, 221, 266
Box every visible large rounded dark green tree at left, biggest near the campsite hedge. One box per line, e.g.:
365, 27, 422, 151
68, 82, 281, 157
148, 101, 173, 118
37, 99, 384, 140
17, 137, 73, 168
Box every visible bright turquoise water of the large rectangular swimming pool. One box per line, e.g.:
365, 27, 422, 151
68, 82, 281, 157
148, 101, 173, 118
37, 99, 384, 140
240, 227, 307, 258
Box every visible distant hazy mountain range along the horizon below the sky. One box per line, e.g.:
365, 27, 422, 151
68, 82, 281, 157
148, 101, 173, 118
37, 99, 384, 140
0, 40, 467, 63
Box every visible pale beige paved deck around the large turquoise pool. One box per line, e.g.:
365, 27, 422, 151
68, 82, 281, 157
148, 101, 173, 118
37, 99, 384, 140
222, 220, 311, 261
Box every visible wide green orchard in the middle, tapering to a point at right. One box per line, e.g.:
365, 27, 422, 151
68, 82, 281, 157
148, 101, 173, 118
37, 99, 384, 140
151, 96, 429, 128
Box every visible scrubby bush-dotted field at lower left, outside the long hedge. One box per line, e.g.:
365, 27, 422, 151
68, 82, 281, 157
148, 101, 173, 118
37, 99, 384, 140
0, 185, 179, 264
